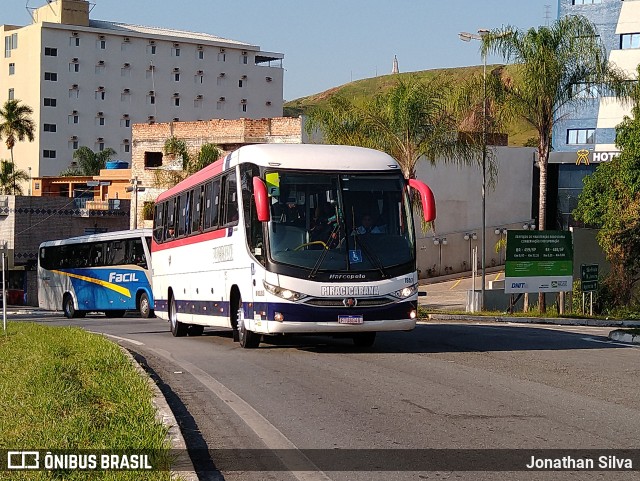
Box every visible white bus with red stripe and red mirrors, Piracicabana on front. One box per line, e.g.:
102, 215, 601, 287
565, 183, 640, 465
151, 144, 435, 348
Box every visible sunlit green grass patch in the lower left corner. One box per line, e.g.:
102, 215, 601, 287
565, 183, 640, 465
0, 322, 175, 480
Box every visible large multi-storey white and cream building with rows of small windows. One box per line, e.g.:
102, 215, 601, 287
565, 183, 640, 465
0, 0, 284, 181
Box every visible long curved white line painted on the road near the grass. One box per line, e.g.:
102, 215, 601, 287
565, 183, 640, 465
153, 349, 331, 481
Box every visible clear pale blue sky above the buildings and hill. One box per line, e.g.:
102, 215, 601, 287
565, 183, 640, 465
6, 0, 558, 100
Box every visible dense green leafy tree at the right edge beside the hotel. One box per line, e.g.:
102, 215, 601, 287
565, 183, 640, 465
573, 68, 640, 308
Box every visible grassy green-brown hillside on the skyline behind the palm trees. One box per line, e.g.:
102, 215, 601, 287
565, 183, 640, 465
284, 65, 536, 147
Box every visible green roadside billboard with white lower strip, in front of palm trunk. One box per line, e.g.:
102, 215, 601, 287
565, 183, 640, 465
504, 230, 573, 294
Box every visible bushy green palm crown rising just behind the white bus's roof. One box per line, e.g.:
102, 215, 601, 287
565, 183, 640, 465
307, 76, 478, 179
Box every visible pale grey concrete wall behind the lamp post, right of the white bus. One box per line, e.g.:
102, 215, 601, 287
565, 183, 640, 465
416, 147, 535, 278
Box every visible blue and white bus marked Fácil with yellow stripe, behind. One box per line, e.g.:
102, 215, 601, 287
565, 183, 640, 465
38, 229, 153, 318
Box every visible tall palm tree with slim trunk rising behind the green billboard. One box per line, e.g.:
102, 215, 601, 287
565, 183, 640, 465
482, 16, 629, 312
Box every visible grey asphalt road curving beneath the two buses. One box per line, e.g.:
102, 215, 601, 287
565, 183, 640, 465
16, 315, 640, 481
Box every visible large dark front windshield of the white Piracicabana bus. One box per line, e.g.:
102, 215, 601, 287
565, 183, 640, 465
265, 170, 415, 278
